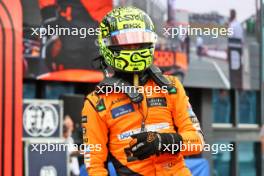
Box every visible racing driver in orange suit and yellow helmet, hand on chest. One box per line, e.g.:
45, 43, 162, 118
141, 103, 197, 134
82, 7, 204, 176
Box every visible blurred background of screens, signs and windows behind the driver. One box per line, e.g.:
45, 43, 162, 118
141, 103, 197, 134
0, 0, 264, 176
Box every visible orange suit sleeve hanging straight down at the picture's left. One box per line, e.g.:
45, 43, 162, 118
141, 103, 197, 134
82, 96, 108, 176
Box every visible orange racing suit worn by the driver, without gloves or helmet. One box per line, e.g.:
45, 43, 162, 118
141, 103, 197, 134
82, 76, 204, 176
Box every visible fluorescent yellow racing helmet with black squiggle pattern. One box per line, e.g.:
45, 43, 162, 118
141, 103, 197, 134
98, 7, 157, 73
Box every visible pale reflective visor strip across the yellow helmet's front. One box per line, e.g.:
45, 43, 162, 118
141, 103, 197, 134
103, 30, 157, 46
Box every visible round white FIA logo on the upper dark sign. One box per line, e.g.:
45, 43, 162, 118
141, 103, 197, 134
23, 103, 59, 137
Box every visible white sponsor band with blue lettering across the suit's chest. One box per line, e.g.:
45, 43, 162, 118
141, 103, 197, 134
117, 123, 170, 141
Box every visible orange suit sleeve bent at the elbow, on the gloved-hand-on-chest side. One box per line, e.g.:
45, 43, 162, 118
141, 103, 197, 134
172, 77, 204, 155
